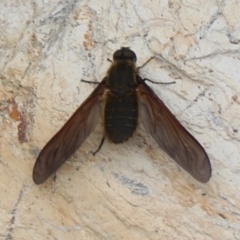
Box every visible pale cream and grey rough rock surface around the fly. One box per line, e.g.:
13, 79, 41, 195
0, 0, 240, 240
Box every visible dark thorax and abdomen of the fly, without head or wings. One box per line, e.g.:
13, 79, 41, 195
104, 60, 138, 143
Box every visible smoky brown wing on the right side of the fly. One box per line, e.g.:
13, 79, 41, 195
137, 80, 211, 183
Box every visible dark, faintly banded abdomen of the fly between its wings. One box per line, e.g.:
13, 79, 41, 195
104, 92, 138, 143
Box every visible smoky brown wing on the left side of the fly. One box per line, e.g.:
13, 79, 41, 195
33, 80, 105, 184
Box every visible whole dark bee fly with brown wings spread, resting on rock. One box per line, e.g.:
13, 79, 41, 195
33, 47, 211, 184
